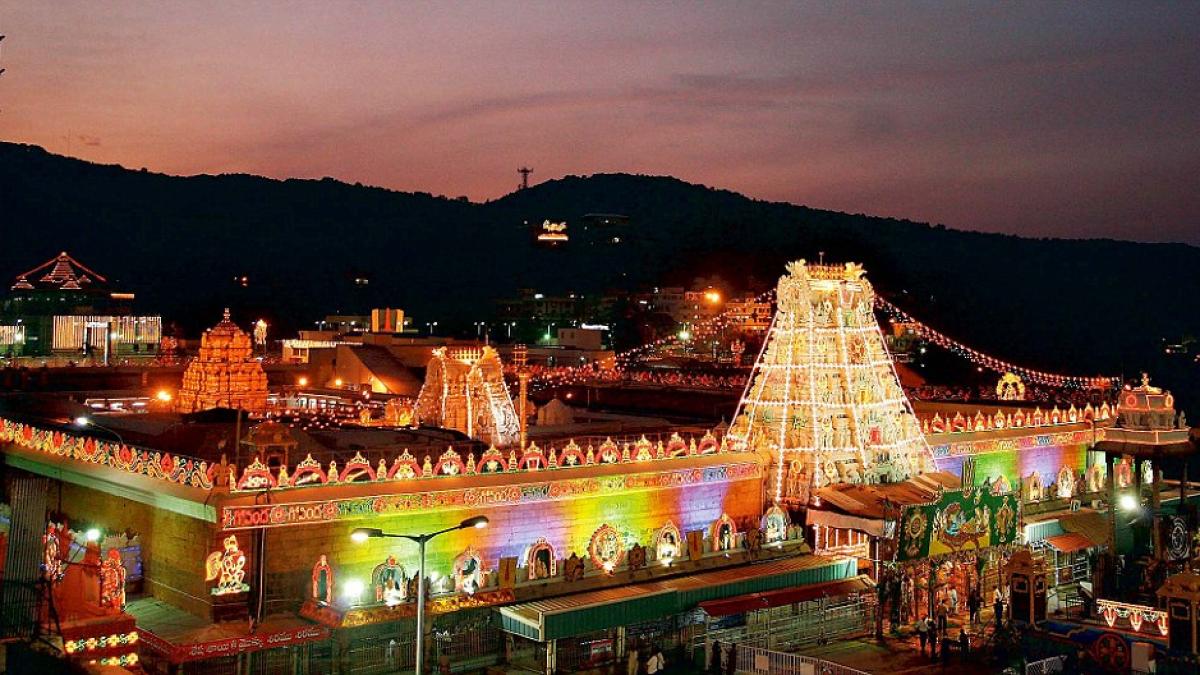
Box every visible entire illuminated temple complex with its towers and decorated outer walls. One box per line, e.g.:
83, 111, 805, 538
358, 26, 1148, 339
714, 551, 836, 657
0, 255, 1198, 675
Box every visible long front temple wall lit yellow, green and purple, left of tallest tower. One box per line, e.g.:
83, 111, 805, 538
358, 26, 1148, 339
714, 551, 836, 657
255, 461, 762, 598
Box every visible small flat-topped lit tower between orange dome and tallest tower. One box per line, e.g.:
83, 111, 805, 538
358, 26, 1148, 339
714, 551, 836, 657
416, 347, 520, 448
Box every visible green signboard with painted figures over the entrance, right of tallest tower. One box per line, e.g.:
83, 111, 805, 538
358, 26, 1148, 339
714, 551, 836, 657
896, 488, 1021, 561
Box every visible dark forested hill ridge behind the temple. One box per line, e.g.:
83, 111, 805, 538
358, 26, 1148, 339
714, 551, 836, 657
0, 143, 1200, 408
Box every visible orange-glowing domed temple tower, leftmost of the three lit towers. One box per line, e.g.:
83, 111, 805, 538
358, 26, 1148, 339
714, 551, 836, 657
176, 310, 266, 413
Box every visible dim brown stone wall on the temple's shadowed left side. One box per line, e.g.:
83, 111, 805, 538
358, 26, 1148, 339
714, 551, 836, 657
52, 482, 216, 617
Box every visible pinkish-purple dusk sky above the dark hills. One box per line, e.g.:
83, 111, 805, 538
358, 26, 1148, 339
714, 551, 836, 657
0, 0, 1200, 244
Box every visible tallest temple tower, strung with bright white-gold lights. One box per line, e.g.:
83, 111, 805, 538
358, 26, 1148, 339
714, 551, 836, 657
728, 261, 934, 504
